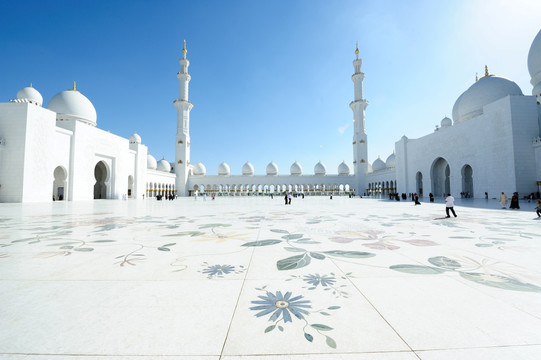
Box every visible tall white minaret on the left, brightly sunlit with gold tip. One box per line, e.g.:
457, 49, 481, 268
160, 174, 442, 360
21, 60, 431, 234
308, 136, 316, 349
173, 40, 193, 196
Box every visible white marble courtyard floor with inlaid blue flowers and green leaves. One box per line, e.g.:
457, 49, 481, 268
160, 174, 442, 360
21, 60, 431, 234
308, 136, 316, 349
0, 197, 541, 360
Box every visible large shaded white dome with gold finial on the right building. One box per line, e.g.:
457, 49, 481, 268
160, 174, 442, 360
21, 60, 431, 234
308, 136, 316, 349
453, 76, 523, 123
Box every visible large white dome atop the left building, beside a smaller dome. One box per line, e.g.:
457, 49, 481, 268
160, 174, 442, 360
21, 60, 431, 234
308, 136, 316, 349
47, 86, 97, 126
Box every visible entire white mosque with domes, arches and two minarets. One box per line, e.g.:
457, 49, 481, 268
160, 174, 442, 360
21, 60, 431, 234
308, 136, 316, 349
0, 31, 541, 202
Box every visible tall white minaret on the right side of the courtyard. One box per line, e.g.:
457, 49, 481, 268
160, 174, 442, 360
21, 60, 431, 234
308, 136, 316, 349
349, 44, 368, 194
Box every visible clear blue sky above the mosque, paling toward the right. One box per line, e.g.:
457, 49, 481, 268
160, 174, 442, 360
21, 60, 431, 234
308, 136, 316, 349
0, 0, 541, 174
